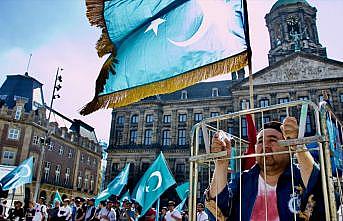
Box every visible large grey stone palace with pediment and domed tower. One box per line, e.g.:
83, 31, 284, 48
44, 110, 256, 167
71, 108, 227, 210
105, 0, 343, 200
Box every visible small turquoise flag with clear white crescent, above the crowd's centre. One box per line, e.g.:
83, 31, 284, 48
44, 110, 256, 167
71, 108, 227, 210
131, 153, 176, 216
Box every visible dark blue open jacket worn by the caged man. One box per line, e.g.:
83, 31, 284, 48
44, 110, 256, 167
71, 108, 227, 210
218, 164, 325, 221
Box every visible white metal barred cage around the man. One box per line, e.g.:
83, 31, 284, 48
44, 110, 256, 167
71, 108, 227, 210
188, 100, 343, 221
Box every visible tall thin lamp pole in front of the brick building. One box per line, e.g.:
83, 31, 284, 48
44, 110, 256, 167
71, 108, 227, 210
34, 67, 63, 202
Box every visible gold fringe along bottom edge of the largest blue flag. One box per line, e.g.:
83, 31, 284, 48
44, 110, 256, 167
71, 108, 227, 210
80, 51, 248, 115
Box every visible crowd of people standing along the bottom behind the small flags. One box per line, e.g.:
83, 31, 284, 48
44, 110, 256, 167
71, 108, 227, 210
0, 197, 208, 221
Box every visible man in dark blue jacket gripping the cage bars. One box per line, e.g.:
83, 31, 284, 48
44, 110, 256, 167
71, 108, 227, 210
210, 117, 325, 221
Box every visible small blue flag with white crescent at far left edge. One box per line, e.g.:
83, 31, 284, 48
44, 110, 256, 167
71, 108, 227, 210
0, 157, 33, 190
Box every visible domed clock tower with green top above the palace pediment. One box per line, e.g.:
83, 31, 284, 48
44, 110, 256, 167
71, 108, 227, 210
265, 0, 326, 65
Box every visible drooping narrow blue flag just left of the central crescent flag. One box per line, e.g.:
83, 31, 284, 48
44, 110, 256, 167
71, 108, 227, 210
95, 163, 130, 205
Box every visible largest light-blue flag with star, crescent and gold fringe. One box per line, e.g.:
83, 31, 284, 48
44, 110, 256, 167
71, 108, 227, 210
81, 0, 250, 114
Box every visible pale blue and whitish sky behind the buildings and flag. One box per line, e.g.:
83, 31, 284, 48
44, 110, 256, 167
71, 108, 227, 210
0, 0, 343, 142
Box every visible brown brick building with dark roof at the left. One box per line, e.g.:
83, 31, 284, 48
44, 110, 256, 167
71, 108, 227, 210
0, 75, 102, 201
